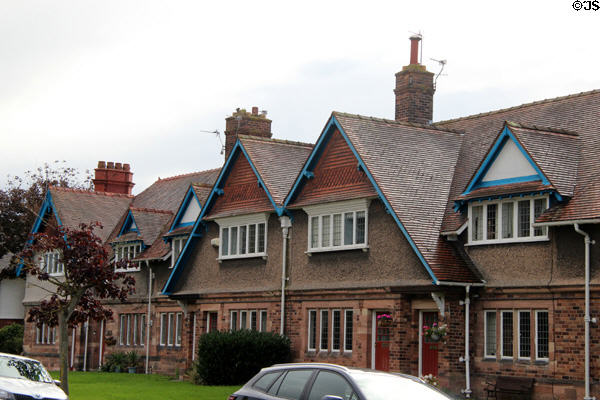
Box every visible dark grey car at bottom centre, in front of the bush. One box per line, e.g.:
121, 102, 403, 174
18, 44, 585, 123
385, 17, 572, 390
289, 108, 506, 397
229, 363, 452, 400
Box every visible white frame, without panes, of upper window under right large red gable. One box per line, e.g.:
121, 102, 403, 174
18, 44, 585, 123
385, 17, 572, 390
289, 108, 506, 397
303, 199, 370, 254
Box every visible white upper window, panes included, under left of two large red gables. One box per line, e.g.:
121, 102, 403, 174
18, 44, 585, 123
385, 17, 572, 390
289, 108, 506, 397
216, 213, 268, 260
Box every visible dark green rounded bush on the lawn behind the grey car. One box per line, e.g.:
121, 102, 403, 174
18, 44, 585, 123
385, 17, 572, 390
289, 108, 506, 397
195, 330, 291, 385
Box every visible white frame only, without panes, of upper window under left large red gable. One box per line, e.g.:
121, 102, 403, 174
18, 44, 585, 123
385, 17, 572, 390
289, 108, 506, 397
215, 213, 269, 261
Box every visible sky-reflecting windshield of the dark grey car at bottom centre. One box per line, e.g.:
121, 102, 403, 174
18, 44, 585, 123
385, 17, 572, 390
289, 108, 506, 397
351, 371, 452, 400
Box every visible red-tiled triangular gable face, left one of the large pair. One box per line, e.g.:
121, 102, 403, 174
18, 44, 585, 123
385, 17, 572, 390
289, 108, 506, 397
206, 152, 273, 218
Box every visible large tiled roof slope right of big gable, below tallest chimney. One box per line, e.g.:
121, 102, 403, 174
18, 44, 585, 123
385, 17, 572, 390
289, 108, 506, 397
333, 112, 479, 282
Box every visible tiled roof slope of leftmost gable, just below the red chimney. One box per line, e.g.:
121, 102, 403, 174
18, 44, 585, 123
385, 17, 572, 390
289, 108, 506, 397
49, 186, 133, 242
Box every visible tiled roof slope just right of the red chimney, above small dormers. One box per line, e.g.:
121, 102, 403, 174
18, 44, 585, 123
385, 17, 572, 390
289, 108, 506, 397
133, 168, 220, 213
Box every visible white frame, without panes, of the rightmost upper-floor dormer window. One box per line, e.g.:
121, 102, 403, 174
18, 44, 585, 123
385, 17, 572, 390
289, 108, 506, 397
467, 194, 549, 246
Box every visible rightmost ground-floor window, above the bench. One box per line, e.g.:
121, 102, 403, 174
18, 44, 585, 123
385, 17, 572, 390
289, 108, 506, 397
483, 309, 549, 361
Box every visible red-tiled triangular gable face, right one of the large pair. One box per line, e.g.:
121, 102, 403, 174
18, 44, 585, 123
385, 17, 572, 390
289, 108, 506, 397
290, 129, 377, 207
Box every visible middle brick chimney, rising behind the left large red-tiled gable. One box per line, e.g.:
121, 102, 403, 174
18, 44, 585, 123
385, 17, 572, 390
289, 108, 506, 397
225, 107, 273, 160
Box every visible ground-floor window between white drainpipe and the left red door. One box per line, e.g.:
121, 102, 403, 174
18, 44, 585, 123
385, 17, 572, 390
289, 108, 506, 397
307, 309, 354, 352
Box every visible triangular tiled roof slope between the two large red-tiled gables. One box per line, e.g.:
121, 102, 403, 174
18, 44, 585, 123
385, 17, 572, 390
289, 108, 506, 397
239, 135, 313, 206
